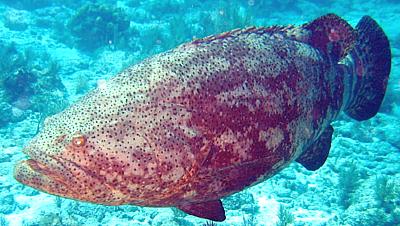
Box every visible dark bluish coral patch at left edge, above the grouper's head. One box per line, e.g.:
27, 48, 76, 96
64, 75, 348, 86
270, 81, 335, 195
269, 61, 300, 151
0, 43, 67, 125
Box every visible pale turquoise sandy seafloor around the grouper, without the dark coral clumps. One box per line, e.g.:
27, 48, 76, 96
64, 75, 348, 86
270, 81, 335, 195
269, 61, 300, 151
0, 0, 400, 226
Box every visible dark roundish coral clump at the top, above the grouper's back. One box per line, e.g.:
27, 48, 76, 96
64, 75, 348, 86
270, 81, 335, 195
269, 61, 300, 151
67, 4, 130, 50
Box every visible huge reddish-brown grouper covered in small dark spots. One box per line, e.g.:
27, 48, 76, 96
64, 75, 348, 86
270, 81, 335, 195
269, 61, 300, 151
15, 14, 391, 221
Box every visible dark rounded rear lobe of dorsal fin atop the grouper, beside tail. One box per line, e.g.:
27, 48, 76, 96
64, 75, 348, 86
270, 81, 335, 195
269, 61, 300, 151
302, 14, 357, 61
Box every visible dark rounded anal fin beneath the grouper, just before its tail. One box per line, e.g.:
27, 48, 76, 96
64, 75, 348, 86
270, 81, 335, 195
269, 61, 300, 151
296, 125, 333, 171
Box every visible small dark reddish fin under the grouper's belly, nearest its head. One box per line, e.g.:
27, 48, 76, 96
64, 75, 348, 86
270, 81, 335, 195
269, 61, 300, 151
177, 200, 226, 221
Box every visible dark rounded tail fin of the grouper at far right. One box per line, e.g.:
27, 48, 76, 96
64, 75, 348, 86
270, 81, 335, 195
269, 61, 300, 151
344, 16, 391, 121
